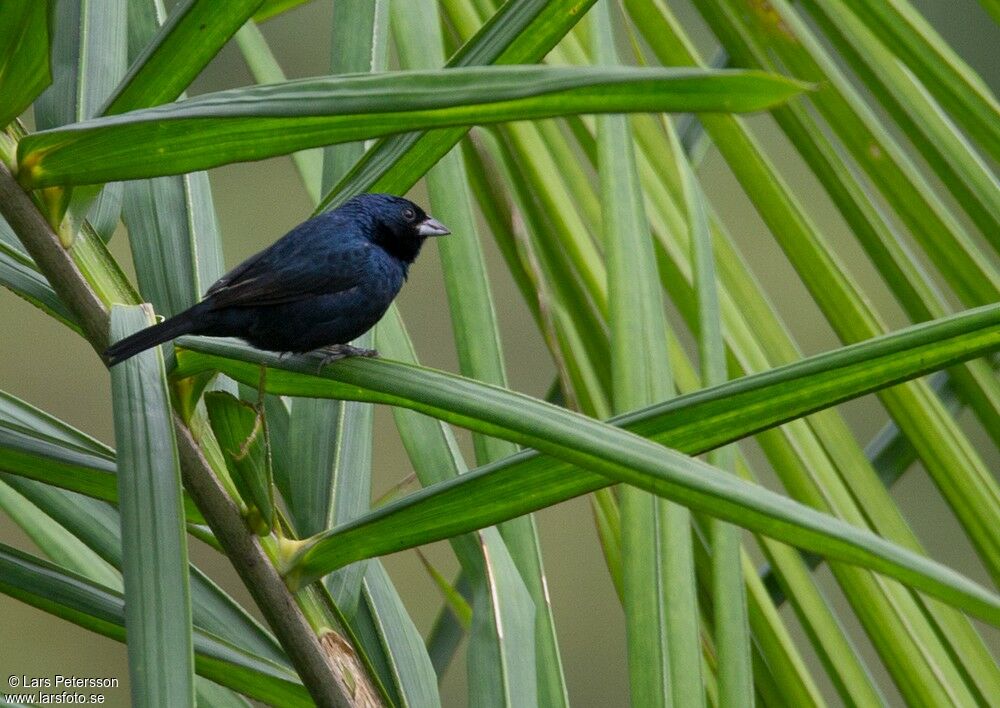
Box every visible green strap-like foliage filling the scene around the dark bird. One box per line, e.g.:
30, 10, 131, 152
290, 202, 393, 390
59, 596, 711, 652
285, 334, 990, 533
0, 0, 1000, 707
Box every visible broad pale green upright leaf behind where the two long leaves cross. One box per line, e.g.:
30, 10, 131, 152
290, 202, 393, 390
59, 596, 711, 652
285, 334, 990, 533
591, 0, 688, 707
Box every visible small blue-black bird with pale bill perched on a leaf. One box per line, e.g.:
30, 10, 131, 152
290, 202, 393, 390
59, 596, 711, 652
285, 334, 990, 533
104, 194, 450, 367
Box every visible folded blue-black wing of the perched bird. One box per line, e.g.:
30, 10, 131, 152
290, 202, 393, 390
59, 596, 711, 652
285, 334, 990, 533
205, 236, 366, 308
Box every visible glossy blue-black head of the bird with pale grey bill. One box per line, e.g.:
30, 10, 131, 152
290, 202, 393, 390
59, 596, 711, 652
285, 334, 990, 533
352, 194, 451, 264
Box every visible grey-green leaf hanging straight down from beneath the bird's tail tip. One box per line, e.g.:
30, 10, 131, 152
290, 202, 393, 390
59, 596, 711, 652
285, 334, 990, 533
111, 307, 194, 706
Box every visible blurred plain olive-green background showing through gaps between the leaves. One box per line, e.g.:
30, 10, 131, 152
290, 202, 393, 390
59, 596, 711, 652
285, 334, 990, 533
0, 0, 1000, 706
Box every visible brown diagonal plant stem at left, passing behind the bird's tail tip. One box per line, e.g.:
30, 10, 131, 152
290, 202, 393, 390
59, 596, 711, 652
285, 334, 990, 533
0, 163, 381, 708
